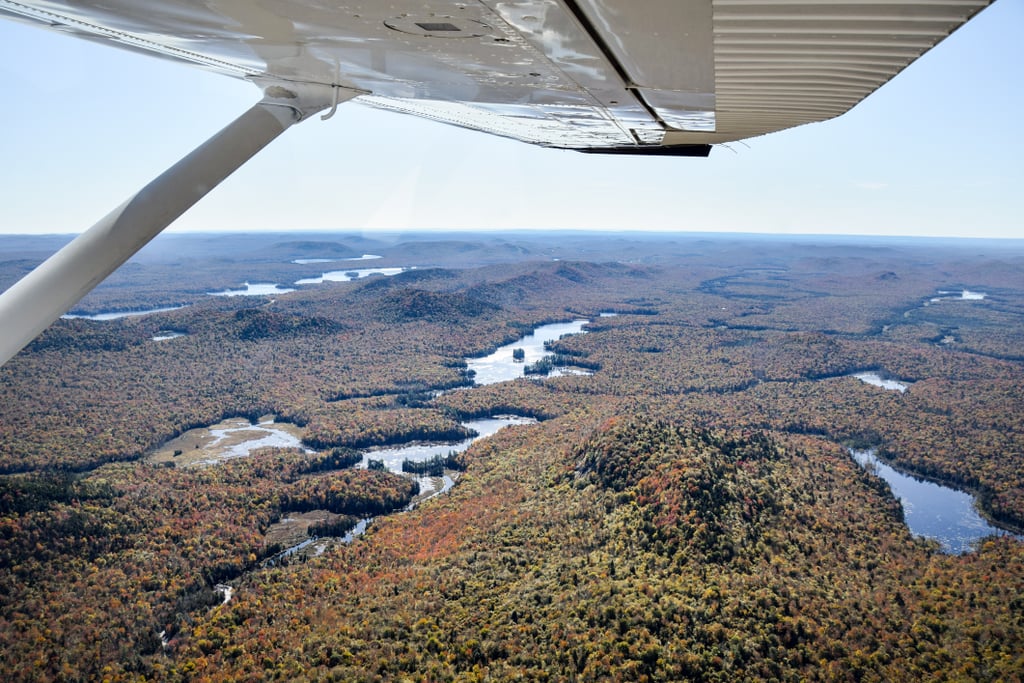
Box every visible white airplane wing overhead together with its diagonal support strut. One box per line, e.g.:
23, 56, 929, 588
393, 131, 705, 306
0, 0, 990, 364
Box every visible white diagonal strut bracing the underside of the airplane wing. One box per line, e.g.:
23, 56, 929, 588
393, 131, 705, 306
0, 86, 348, 366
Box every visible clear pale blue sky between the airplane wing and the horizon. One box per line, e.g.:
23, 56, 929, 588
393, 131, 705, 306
0, 0, 1024, 239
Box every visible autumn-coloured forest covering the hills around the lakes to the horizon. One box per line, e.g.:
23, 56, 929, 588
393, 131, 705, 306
0, 232, 1024, 682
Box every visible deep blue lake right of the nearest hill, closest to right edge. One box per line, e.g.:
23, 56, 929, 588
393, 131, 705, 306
850, 449, 1009, 555
